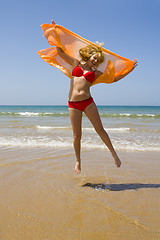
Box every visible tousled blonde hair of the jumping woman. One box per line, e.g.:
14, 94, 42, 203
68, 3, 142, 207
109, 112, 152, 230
79, 44, 104, 63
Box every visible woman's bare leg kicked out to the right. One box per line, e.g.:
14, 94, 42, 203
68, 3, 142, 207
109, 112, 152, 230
84, 102, 121, 167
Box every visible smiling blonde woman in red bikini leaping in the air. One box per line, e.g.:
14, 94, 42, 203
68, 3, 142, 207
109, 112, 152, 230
57, 38, 137, 174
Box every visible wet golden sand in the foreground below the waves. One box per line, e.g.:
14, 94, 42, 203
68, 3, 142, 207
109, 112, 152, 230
0, 148, 160, 240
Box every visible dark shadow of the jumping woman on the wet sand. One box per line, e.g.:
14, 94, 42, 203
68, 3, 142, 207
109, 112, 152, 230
82, 183, 160, 191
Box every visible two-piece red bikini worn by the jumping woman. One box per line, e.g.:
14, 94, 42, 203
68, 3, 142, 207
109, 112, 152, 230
68, 66, 95, 111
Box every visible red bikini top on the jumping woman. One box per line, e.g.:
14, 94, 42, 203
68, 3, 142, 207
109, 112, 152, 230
72, 66, 95, 83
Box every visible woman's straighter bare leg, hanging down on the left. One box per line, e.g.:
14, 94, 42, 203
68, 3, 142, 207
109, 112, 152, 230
69, 108, 82, 174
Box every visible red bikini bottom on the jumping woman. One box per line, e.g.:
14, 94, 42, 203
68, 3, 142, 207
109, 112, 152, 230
68, 97, 93, 111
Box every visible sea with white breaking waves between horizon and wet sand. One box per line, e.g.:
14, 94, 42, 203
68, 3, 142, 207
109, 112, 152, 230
0, 106, 160, 152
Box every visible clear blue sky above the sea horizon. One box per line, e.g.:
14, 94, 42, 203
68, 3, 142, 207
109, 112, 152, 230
0, 0, 160, 105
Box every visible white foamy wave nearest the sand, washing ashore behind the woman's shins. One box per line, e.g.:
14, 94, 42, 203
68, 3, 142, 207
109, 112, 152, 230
0, 136, 160, 152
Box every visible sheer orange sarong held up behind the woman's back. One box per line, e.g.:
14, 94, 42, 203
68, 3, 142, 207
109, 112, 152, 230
38, 21, 134, 85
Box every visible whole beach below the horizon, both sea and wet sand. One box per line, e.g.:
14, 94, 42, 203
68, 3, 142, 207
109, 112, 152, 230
0, 106, 160, 240
